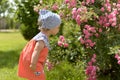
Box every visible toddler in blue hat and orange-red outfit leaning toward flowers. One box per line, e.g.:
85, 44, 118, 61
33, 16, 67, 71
18, 10, 61, 80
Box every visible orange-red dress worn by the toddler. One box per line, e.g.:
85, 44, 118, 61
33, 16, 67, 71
18, 32, 49, 80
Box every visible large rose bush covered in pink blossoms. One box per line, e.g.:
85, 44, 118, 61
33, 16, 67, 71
16, 0, 120, 80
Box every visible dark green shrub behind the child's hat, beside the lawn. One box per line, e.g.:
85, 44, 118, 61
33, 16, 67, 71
17, 0, 39, 40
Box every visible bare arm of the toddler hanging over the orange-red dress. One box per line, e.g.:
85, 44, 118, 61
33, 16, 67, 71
30, 41, 45, 70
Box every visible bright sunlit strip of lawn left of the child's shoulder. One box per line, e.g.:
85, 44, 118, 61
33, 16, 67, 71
0, 32, 26, 50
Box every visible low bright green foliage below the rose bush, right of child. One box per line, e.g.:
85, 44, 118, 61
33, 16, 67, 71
46, 61, 86, 80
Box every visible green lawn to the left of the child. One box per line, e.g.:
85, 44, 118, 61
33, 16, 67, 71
0, 32, 27, 80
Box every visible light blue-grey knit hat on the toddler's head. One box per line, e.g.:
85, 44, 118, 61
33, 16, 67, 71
39, 10, 61, 29
